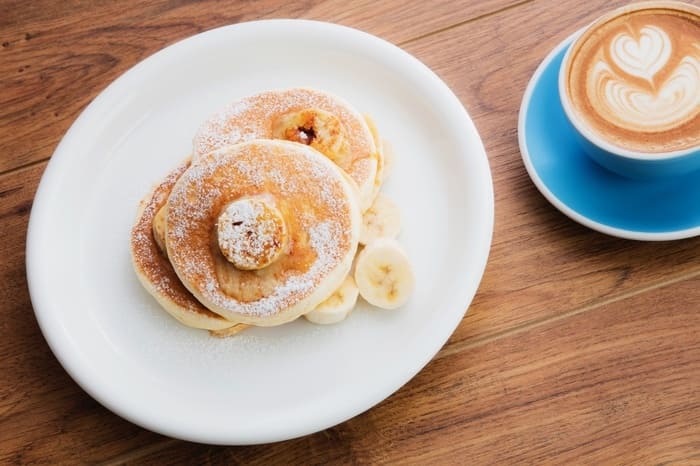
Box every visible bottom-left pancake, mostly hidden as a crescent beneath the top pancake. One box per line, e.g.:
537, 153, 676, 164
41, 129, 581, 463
131, 161, 245, 333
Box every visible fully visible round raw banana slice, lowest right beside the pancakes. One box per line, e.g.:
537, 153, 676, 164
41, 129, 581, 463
355, 238, 415, 309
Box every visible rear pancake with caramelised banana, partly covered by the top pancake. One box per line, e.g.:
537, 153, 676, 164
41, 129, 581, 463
193, 88, 381, 210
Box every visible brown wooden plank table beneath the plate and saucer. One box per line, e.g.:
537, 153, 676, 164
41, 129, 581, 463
0, 0, 700, 464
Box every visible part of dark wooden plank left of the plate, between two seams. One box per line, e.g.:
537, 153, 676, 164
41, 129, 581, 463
0, 164, 164, 464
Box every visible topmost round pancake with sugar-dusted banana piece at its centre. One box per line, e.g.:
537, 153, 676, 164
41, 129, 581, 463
165, 140, 361, 326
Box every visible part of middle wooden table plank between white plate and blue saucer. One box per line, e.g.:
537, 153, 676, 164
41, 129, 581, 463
398, 0, 700, 348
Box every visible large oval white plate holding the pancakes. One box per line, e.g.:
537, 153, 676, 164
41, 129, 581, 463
27, 20, 493, 444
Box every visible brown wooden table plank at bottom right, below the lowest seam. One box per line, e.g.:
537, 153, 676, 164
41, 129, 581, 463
121, 276, 700, 465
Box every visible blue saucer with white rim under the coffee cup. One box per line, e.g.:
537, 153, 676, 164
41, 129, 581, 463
518, 36, 700, 240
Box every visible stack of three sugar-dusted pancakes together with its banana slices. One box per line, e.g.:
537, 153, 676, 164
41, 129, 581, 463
131, 88, 414, 336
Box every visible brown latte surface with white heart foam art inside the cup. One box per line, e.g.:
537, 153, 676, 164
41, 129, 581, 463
567, 4, 700, 152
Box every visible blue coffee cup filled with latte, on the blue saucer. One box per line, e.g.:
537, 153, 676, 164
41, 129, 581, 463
559, 1, 700, 179
